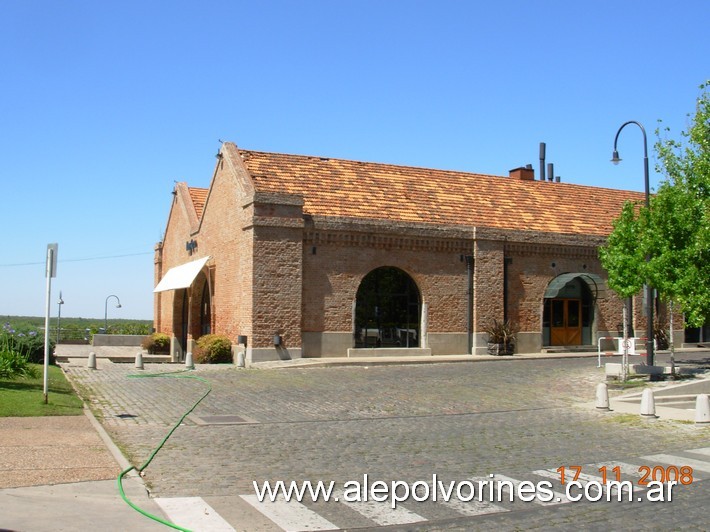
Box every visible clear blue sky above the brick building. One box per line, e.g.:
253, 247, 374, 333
0, 0, 710, 319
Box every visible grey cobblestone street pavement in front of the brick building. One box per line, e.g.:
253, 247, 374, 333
63, 358, 710, 530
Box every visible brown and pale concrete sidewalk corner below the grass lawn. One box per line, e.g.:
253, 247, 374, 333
0, 411, 165, 532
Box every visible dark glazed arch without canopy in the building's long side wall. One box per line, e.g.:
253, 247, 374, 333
355, 266, 421, 347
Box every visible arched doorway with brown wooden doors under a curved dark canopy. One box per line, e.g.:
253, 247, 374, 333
542, 273, 604, 346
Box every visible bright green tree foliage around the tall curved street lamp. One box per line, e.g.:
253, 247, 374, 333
599, 84, 710, 327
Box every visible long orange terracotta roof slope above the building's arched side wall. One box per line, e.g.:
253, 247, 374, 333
240, 150, 643, 235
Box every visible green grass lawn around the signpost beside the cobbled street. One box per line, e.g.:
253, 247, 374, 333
0, 364, 83, 417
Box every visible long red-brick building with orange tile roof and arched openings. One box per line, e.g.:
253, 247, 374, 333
154, 142, 656, 361
